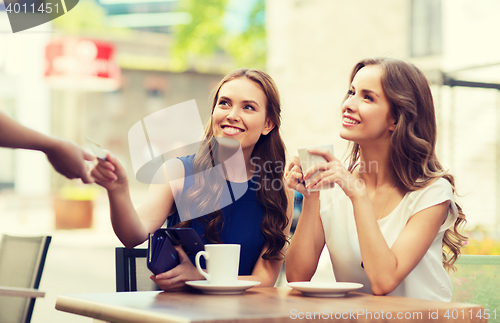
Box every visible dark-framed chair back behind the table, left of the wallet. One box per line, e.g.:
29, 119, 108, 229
115, 247, 161, 292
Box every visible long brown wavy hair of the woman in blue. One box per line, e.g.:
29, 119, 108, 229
178, 69, 289, 260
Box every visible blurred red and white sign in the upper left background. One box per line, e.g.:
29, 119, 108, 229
45, 39, 121, 91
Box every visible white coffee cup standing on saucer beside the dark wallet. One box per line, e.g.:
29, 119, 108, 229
195, 244, 240, 286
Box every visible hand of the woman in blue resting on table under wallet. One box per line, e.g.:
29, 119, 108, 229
150, 246, 205, 292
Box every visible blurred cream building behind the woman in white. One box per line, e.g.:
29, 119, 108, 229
266, 0, 500, 231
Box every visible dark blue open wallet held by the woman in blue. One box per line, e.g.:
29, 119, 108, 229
147, 228, 205, 275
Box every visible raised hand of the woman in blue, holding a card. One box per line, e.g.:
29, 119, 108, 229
90, 152, 127, 191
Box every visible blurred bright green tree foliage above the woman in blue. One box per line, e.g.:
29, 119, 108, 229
171, 0, 266, 71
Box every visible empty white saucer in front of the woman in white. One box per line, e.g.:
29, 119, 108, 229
288, 282, 363, 297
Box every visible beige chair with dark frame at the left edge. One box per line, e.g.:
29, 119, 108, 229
0, 234, 51, 323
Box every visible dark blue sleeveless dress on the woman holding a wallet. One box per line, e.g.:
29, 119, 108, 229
167, 155, 265, 275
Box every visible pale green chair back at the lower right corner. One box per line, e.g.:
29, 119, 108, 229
451, 255, 500, 315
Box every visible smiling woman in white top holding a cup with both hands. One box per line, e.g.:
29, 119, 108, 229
286, 58, 466, 301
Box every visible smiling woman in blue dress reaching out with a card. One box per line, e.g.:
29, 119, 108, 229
91, 69, 293, 290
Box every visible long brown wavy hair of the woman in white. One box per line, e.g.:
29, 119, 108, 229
348, 58, 467, 271
